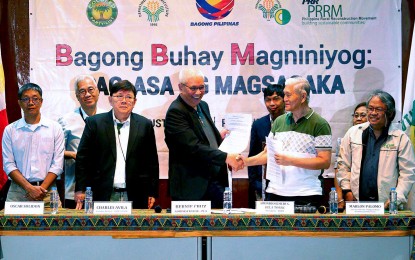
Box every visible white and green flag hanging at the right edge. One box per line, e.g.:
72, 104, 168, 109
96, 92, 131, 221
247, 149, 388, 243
402, 22, 415, 147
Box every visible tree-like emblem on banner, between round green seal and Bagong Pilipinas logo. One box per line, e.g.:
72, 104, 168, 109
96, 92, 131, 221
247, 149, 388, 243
138, 0, 169, 26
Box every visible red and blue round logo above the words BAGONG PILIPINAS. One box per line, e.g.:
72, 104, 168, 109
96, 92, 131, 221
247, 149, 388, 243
196, 0, 234, 20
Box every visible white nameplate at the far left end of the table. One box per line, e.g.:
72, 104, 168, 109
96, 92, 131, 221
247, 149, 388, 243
4, 201, 45, 215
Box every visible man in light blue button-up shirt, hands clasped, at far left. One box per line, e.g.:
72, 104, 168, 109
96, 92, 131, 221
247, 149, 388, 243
2, 83, 64, 206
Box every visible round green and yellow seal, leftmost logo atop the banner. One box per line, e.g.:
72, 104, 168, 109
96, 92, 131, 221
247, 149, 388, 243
86, 0, 118, 27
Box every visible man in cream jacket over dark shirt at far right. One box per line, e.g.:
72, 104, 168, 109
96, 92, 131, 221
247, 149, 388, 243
337, 90, 415, 208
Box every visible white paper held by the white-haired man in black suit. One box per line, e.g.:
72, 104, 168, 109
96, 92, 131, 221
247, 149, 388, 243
219, 113, 252, 153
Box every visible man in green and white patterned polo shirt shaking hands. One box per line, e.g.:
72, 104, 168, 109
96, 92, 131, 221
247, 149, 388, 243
244, 76, 331, 207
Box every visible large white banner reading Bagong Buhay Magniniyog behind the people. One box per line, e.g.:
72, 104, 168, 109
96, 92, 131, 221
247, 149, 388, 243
30, 0, 401, 178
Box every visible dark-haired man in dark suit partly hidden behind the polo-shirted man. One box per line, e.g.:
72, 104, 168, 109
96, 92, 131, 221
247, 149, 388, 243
248, 84, 285, 208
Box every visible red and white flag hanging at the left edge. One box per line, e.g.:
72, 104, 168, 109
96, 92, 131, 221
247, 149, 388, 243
0, 45, 8, 190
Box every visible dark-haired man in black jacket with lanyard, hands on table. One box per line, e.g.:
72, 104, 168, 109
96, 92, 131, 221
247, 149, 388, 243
75, 80, 159, 209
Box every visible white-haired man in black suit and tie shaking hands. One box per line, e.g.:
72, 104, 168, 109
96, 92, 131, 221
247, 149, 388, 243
165, 68, 243, 208
